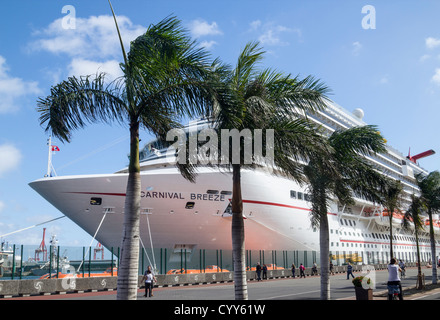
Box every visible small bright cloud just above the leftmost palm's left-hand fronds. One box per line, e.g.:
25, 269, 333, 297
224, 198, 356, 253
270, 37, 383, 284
68, 58, 123, 81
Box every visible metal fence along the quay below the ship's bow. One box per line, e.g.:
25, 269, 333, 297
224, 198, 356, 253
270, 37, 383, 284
0, 245, 319, 280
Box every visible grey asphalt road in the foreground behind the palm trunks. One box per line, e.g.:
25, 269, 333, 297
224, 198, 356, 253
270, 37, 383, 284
7, 268, 440, 301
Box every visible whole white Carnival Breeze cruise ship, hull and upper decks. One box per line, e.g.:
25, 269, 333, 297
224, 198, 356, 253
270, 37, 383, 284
30, 102, 440, 264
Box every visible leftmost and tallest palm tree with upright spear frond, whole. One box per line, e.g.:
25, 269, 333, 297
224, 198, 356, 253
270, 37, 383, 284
38, 11, 220, 300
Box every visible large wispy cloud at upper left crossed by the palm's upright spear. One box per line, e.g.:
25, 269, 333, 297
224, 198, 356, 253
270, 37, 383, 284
29, 15, 146, 61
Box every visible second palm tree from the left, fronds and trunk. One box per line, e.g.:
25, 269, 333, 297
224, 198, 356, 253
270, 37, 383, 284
213, 42, 328, 300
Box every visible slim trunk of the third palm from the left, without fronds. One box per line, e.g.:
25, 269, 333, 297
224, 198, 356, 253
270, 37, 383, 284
319, 207, 330, 300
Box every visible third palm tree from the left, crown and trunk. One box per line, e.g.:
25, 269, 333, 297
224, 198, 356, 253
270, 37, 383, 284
304, 126, 387, 300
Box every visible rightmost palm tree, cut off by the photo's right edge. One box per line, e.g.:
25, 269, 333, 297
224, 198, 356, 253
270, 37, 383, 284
416, 171, 440, 284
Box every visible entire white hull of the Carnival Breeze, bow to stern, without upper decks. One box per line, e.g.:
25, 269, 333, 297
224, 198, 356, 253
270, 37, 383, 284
31, 164, 438, 261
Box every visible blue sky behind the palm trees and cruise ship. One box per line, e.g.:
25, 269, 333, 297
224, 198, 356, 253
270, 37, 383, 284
0, 0, 440, 246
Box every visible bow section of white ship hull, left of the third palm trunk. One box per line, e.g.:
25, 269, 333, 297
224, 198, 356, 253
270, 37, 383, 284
30, 168, 318, 250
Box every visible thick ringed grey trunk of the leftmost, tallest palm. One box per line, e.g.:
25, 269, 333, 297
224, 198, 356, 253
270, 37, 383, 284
116, 121, 141, 300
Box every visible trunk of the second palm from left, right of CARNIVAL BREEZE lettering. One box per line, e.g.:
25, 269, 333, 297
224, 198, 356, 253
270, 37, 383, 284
231, 164, 248, 300
